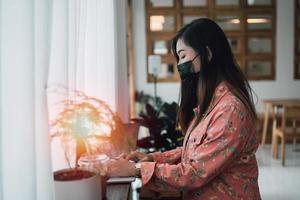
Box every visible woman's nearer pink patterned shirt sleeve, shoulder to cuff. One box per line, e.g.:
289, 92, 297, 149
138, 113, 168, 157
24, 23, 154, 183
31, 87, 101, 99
141, 105, 250, 191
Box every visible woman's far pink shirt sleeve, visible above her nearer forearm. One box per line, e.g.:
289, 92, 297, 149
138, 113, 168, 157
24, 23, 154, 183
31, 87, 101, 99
152, 147, 182, 164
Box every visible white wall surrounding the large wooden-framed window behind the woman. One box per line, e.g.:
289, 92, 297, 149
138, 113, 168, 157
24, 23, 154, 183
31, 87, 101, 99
133, 0, 300, 111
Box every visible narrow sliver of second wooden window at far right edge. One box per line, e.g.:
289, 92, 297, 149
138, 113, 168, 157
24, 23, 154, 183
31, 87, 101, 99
294, 0, 300, 79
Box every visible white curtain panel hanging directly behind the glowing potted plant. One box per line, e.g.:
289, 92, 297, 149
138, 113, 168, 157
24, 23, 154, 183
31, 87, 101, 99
48, 0, 129, 171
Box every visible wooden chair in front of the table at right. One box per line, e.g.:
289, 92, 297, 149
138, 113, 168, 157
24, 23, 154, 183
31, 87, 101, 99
272, 105, 300, 166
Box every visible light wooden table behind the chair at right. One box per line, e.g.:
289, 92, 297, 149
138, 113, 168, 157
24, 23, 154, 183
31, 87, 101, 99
261, 99, 300, 145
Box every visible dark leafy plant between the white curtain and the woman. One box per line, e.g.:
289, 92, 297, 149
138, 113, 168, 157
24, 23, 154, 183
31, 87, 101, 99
132, 93, 183, 152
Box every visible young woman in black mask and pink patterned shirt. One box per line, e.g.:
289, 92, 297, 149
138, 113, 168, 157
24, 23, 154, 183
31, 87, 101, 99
109, 18, 260, 200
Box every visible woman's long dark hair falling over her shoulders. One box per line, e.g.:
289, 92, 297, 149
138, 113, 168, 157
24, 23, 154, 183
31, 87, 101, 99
172, 18, 257, 133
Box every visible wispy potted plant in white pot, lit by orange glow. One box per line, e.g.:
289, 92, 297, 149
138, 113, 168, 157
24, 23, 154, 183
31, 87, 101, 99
51, 92, 131, 200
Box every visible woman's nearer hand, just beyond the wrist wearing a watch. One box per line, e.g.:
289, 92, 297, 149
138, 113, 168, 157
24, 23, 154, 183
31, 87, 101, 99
107, 158, 136, 177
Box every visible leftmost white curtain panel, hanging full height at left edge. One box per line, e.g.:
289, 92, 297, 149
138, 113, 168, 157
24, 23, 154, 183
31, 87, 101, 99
0, 0, 53, 200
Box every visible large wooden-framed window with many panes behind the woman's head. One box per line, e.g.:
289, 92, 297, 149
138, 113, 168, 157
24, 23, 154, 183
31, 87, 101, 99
146, 0, 276, 82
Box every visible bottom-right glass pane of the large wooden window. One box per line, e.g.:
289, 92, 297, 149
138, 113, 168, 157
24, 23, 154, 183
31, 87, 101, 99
246, 61, 272, 77
